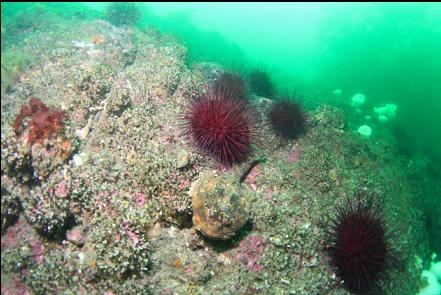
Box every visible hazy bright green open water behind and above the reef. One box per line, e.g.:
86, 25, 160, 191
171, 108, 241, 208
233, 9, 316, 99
1, 3, 441, 295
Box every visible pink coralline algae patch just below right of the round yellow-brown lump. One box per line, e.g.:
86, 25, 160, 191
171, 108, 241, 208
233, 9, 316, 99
236, 236, 265, 272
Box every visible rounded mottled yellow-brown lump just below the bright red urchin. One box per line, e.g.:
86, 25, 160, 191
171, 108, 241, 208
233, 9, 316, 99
190, 172, 248, 240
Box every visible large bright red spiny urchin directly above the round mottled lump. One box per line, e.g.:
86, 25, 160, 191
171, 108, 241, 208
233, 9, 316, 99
184, 87, 253, 166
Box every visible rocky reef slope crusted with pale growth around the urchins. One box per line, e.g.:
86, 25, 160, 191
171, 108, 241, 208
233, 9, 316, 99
1, 12, 440, 295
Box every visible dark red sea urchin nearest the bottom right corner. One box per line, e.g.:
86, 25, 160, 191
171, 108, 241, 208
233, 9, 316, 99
326, 200, 392, 294
